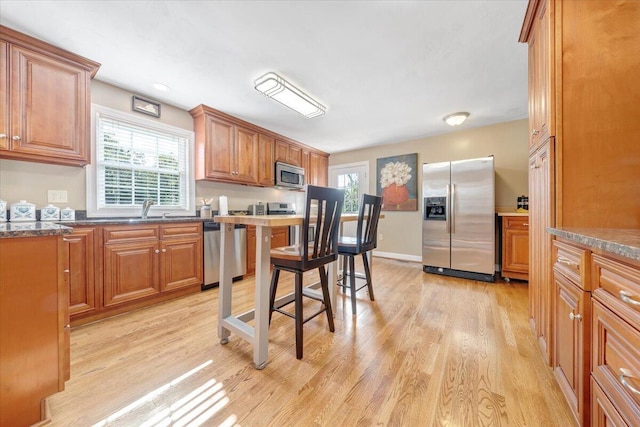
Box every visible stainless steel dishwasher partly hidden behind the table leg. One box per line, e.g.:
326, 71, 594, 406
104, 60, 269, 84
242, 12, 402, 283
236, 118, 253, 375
202, 221, 247, 290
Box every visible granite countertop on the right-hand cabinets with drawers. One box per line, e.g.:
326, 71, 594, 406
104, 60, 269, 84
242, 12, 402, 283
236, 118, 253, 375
547, 227, 640, 261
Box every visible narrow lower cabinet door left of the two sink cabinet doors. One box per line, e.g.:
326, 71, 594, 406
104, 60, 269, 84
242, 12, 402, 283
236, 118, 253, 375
64, 227, 98, 316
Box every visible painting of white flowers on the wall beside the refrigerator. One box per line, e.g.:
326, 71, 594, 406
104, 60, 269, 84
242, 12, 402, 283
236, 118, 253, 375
376, 153, 418, 211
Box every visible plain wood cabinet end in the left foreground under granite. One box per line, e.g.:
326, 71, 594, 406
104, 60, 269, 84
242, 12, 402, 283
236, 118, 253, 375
0, 235, 69, 426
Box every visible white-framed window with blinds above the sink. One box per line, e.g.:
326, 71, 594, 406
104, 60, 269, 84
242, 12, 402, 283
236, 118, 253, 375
89, 106, 193, 215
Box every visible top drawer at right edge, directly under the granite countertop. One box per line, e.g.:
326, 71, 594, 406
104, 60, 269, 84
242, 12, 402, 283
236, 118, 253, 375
591, 254, 640, 330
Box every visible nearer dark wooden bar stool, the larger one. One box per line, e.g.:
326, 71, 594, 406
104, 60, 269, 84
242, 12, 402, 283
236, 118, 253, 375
269, 185, 344, 359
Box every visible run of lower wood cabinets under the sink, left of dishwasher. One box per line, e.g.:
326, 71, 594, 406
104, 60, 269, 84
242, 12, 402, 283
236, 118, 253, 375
66, 222, 203, 325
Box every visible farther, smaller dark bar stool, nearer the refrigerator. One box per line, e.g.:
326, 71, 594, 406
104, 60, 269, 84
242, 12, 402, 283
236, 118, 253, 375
338, 194, 382, 315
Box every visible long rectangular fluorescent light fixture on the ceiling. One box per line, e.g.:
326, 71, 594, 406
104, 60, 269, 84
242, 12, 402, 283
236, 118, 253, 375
254, 73, 327, 119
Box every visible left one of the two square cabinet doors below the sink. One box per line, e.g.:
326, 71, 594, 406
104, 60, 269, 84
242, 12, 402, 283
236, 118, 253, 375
104, 240, 160, 307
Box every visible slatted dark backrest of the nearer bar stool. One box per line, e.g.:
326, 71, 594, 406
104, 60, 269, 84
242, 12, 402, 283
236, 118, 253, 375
302, 185, 344, 266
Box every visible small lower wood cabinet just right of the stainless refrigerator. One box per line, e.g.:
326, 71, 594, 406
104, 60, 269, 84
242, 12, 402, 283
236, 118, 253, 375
502, 215, 529, 280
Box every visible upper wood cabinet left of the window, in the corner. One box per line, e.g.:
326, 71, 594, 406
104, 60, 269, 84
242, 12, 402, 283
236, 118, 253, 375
0, 26, 99, 166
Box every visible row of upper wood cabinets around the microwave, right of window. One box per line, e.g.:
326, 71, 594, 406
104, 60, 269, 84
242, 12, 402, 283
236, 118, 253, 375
189, 105, 329, 187
